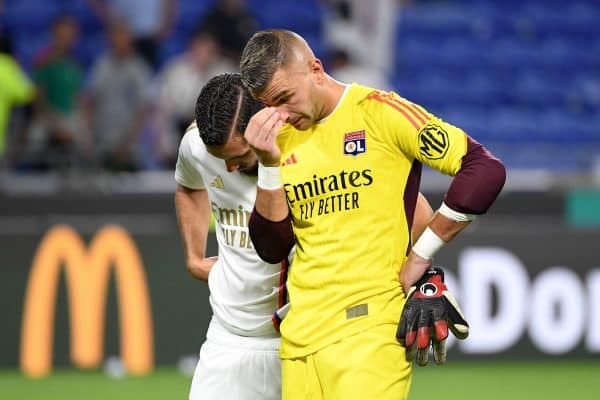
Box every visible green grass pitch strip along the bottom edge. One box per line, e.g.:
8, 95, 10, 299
0, 361, 600, 400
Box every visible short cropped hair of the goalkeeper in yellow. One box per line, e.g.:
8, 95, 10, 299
240, 29, 299, 96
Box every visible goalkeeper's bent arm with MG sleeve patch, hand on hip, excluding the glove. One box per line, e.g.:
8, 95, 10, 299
362, 91, 506, 282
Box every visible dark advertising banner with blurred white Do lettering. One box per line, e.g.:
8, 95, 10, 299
436, 228, 600, 358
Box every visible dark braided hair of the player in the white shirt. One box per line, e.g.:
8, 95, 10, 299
196, 74, 263, 146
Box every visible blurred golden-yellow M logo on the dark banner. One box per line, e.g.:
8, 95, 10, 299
20, 225, 154, 377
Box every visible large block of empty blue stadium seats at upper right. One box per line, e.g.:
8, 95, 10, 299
393, 0, 600, 171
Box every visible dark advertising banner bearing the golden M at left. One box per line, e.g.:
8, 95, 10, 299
0, 225, 210, 376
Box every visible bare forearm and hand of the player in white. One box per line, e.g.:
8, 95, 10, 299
175, 184, 217, 281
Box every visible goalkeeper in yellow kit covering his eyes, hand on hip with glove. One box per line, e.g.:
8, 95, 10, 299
241, 30, 506, 400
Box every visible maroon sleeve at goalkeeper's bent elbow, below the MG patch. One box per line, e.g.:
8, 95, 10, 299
444, 136, 506, 214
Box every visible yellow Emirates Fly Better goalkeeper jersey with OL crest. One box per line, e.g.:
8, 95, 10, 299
278, 84, 467, 358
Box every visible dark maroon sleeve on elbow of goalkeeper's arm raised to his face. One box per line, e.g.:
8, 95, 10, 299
248, 208, 294, 264
